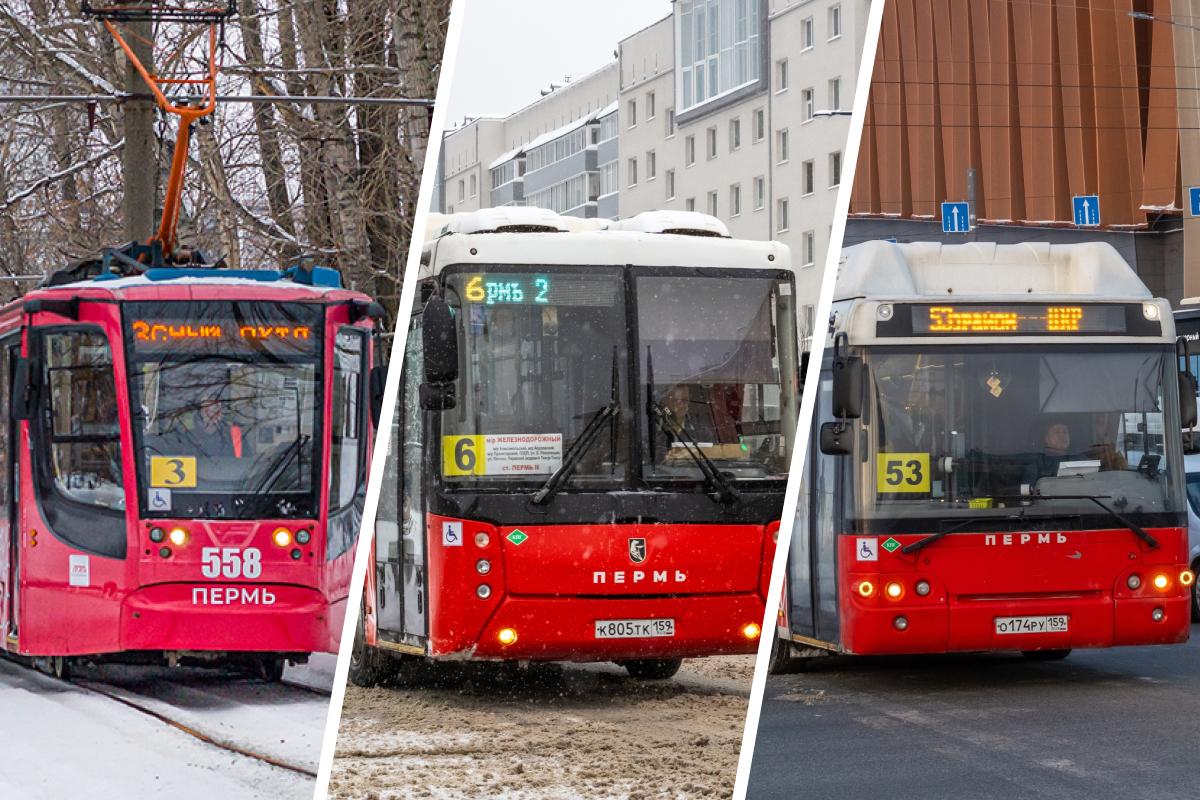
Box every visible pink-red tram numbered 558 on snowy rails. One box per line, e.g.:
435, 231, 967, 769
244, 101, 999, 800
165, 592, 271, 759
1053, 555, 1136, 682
0, 267, 382, 679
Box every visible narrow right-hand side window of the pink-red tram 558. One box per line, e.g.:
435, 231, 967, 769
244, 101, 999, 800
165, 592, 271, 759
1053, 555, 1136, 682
329, 327, 366, 511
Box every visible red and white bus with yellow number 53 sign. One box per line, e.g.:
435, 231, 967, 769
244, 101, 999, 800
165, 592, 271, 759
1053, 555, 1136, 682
773, 242, 1195, 669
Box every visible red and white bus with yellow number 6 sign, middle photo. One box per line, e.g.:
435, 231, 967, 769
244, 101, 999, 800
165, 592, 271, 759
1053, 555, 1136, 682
350, 207, 798, 685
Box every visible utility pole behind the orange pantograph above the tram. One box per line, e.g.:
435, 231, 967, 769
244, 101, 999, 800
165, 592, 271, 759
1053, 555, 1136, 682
121, 20, 158, 242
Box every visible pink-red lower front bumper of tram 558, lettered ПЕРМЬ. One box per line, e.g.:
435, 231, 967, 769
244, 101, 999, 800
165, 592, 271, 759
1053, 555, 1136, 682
120, 583, 340, 652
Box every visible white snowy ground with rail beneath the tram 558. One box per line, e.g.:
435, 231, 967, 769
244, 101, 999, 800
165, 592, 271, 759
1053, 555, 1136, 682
0, 656, 334, 800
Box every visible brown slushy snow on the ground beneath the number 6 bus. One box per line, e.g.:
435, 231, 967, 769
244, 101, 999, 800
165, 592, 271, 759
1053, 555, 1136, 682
329, 656, 754, 800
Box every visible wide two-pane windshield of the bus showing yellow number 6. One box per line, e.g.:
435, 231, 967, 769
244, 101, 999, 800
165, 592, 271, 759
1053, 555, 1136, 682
442, 266, 798, 488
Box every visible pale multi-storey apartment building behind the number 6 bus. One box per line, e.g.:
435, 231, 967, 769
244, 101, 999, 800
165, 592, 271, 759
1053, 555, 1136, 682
442, 0, 870, 331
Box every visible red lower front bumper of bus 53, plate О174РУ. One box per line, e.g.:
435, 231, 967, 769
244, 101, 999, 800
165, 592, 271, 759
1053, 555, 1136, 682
844, 596, 1190, 655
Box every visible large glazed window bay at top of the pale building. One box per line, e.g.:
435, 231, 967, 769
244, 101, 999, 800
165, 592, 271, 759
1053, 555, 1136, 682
676, 0, 764, 110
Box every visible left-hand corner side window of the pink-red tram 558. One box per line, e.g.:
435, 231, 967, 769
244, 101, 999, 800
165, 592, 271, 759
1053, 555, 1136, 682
44, 330, 125, 511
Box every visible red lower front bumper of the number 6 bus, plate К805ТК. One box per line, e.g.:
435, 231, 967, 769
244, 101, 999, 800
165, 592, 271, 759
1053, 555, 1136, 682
453, 594, 764, 661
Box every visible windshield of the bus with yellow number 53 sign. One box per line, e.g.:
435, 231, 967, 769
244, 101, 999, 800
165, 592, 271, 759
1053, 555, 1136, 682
863, 345, 1184, 522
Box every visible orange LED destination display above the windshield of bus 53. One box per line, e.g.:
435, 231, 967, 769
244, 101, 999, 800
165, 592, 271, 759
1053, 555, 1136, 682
876, 303, 1162, 337
